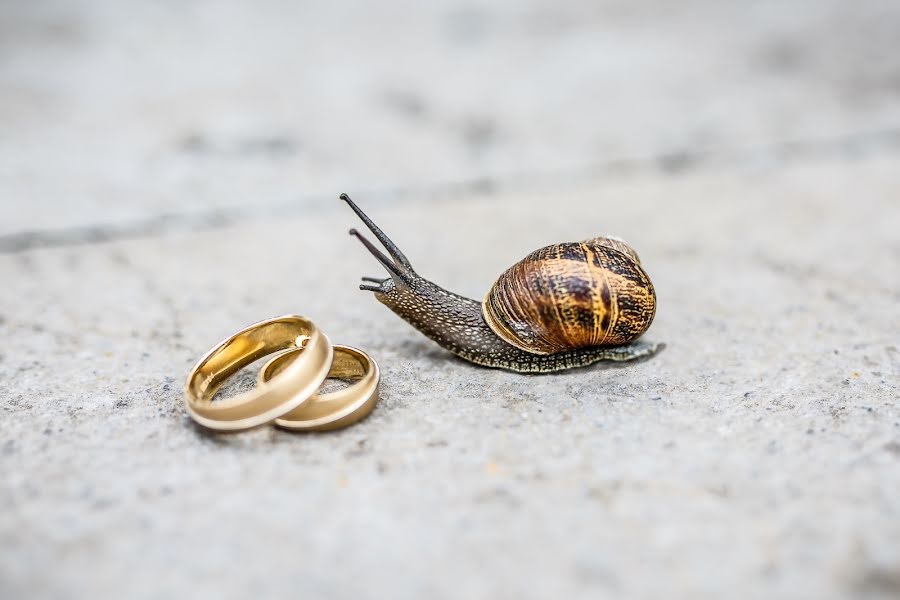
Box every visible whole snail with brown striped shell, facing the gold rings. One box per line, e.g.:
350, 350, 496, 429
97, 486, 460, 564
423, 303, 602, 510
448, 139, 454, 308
341, 194, 662, 373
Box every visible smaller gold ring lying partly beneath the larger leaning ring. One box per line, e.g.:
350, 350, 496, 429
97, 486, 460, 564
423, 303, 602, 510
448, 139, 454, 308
259, 344, 381, 431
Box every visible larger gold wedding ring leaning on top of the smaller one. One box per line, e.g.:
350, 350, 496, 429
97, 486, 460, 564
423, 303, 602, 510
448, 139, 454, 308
184, 315, 334, 431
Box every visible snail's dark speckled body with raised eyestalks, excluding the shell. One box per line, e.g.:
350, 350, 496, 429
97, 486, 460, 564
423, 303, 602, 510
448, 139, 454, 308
341, 194, 662, 373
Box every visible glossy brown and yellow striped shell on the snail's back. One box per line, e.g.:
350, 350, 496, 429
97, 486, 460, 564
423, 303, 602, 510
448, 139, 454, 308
481, 237, 656, 354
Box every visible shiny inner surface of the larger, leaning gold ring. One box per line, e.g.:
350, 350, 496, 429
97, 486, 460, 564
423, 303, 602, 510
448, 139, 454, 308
190, 319, 309, 401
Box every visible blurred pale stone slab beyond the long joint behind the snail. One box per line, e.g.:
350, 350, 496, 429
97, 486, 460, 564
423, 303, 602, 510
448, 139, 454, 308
0, 0, 900, 239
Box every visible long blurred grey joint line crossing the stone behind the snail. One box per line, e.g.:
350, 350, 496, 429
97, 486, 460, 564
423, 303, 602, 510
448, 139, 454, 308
0, 128, 900, 254
